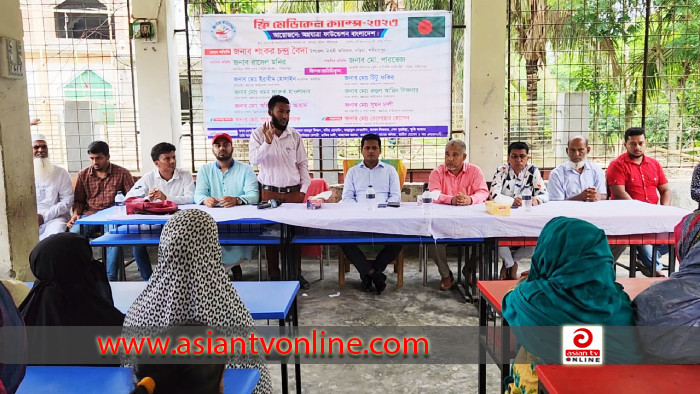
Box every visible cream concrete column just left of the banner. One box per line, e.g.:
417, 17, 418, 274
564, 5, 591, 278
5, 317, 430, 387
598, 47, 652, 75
132, 0, 182, 173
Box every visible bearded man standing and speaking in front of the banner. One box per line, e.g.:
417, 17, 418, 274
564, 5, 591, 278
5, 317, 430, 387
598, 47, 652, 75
249, 96, 311, 289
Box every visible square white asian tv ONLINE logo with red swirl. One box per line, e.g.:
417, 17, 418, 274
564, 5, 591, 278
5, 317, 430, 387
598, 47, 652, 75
562, 326, 603, 365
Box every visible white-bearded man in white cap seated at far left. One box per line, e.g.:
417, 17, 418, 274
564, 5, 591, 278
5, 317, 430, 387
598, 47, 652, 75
32, 134, 73, 241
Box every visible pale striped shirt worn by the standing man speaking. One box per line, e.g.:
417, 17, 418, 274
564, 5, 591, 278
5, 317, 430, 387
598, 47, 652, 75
248, 127, 311, 193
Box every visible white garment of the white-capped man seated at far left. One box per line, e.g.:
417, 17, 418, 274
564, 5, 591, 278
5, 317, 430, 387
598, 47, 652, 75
34, 165, 73, 223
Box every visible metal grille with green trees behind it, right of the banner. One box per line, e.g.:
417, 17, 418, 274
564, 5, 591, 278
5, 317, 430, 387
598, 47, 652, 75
506, 0, 700, 168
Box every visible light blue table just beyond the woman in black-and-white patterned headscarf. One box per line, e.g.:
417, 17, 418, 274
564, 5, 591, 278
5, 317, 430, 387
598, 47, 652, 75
27, 281, 301, 393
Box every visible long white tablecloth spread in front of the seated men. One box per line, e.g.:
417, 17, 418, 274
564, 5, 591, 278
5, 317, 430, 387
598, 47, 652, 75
105, 200, 690, 238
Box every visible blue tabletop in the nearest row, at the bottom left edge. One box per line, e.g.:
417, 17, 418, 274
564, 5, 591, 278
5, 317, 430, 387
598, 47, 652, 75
17, 366, 260, 394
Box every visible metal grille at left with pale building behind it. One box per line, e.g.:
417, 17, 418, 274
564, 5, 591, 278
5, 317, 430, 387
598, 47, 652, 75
20, 0, 140, 172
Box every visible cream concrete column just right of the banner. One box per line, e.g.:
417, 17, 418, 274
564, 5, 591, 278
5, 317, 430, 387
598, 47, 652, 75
464, 0, 507, 174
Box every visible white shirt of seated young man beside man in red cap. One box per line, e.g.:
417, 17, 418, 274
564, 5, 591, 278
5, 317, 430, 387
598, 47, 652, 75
126, 168, 194, 205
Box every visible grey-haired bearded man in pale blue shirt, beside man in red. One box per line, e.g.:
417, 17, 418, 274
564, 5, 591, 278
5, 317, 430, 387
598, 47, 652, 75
547, 135, 608, 202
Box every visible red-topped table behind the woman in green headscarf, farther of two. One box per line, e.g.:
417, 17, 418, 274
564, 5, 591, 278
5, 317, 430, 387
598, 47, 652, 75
477, 278, 666, 394
